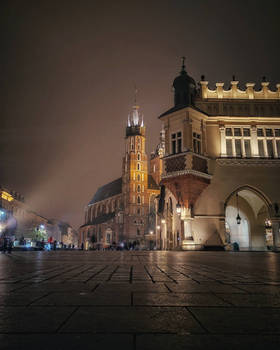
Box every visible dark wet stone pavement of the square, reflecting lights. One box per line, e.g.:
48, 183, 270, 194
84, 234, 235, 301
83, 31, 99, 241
0, 251, 280, 350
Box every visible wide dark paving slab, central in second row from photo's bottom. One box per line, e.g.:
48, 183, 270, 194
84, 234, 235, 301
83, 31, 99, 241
61, 306, 204, 334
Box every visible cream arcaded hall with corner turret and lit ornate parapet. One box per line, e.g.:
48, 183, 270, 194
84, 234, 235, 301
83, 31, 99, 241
156, 61, 280, 250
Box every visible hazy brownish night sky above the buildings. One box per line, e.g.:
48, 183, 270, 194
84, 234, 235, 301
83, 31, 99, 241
0, 0, 280, 228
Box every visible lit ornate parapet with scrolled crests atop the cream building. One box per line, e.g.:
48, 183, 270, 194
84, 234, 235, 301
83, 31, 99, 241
200, 80, 280, 100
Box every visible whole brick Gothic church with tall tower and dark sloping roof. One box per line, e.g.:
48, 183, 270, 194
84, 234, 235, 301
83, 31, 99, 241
79, 105, 162, 249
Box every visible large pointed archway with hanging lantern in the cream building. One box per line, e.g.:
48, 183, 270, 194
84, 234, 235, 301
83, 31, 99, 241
225, 186, 274, 250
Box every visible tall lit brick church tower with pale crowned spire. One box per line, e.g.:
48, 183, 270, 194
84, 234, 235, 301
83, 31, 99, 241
122, 101, 149, 242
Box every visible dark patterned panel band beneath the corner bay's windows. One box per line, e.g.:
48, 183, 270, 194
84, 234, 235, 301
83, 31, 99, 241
162, 151, 211, 178
